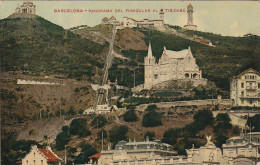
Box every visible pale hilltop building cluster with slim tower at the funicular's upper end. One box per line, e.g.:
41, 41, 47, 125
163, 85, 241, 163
102, 9, 164, 29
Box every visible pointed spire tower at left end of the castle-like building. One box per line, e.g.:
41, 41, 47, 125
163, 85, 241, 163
144, 43, 155, 88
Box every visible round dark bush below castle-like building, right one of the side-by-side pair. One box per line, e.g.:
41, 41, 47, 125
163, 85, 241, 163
142, 111, 162, 127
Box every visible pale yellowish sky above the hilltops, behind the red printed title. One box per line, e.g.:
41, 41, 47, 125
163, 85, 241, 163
0, 1, 260, 36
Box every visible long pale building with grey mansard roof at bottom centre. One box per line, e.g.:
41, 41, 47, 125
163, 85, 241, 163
98, 139, 185, 165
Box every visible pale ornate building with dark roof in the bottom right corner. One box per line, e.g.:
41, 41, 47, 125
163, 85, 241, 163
222, 132, 260, 158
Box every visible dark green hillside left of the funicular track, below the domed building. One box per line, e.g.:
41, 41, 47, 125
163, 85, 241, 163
0, 14, 108, 80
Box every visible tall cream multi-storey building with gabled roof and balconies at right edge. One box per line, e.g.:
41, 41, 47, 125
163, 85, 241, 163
230, 68, 260, 107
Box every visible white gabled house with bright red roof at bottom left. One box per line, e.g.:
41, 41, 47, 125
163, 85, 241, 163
17, 145, 62, 165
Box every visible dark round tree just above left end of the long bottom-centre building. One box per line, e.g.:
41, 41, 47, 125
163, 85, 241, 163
109, 125, 128, 146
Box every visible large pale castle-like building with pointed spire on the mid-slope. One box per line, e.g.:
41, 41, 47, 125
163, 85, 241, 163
144, 44, 207, 89
